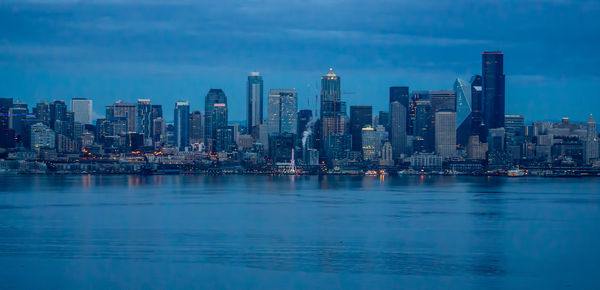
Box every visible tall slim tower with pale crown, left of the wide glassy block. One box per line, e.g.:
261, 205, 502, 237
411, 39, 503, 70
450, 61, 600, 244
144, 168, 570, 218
246, 72, 263, 135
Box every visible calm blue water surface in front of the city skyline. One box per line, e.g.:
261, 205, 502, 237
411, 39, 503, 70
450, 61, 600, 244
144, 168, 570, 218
0, 175, 600, 289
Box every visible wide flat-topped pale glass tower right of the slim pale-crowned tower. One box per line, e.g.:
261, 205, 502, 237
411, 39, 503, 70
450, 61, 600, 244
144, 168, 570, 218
267, 89, 298, 134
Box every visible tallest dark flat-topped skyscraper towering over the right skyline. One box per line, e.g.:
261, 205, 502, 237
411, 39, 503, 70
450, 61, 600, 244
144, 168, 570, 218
482, 51, 505, 130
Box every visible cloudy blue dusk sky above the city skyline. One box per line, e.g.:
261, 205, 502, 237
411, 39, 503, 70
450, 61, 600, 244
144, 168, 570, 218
0, 0, 600, 121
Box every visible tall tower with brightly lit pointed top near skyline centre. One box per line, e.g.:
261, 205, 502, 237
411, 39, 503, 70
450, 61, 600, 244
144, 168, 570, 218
320, 68, 346, 152
